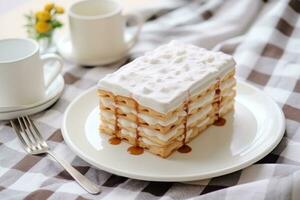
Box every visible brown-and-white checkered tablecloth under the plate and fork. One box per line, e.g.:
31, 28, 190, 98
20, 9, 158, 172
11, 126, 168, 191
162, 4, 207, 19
0, 0, 300, 200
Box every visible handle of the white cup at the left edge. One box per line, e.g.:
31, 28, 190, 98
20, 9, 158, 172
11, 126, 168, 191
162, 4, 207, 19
41, 53, 64, 88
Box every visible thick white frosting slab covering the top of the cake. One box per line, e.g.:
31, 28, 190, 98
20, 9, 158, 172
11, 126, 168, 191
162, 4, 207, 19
98, 41, 235, 113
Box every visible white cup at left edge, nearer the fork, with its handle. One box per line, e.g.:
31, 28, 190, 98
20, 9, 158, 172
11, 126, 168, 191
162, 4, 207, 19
0, 38, 63, 107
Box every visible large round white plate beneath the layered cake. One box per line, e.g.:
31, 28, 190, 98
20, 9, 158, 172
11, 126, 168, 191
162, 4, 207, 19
62, 81, 285, 181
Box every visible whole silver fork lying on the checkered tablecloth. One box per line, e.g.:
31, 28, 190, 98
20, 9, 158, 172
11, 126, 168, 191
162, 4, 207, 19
10, 116, 101, 194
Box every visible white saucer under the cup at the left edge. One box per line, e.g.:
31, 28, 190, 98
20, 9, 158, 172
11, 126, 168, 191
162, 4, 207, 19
0, 75, 65, 120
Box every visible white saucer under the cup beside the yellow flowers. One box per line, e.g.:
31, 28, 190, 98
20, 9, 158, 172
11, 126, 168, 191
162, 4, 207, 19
55, 34, 127, 66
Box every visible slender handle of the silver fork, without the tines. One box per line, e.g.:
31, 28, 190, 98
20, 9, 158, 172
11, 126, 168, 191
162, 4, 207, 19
47, 151, 101, 194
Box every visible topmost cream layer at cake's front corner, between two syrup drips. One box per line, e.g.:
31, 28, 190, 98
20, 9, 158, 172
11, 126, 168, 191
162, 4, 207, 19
138, 111, 186, 126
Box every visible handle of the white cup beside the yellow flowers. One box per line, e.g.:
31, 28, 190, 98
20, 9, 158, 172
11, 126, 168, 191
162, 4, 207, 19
124, 13, 144, 50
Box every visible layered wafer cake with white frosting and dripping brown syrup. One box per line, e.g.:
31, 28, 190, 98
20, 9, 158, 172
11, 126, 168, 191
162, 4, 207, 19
98, 41, 236, 158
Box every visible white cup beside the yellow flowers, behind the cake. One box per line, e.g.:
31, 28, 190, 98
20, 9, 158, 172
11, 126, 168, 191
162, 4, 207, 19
68, 0, 143, 64
